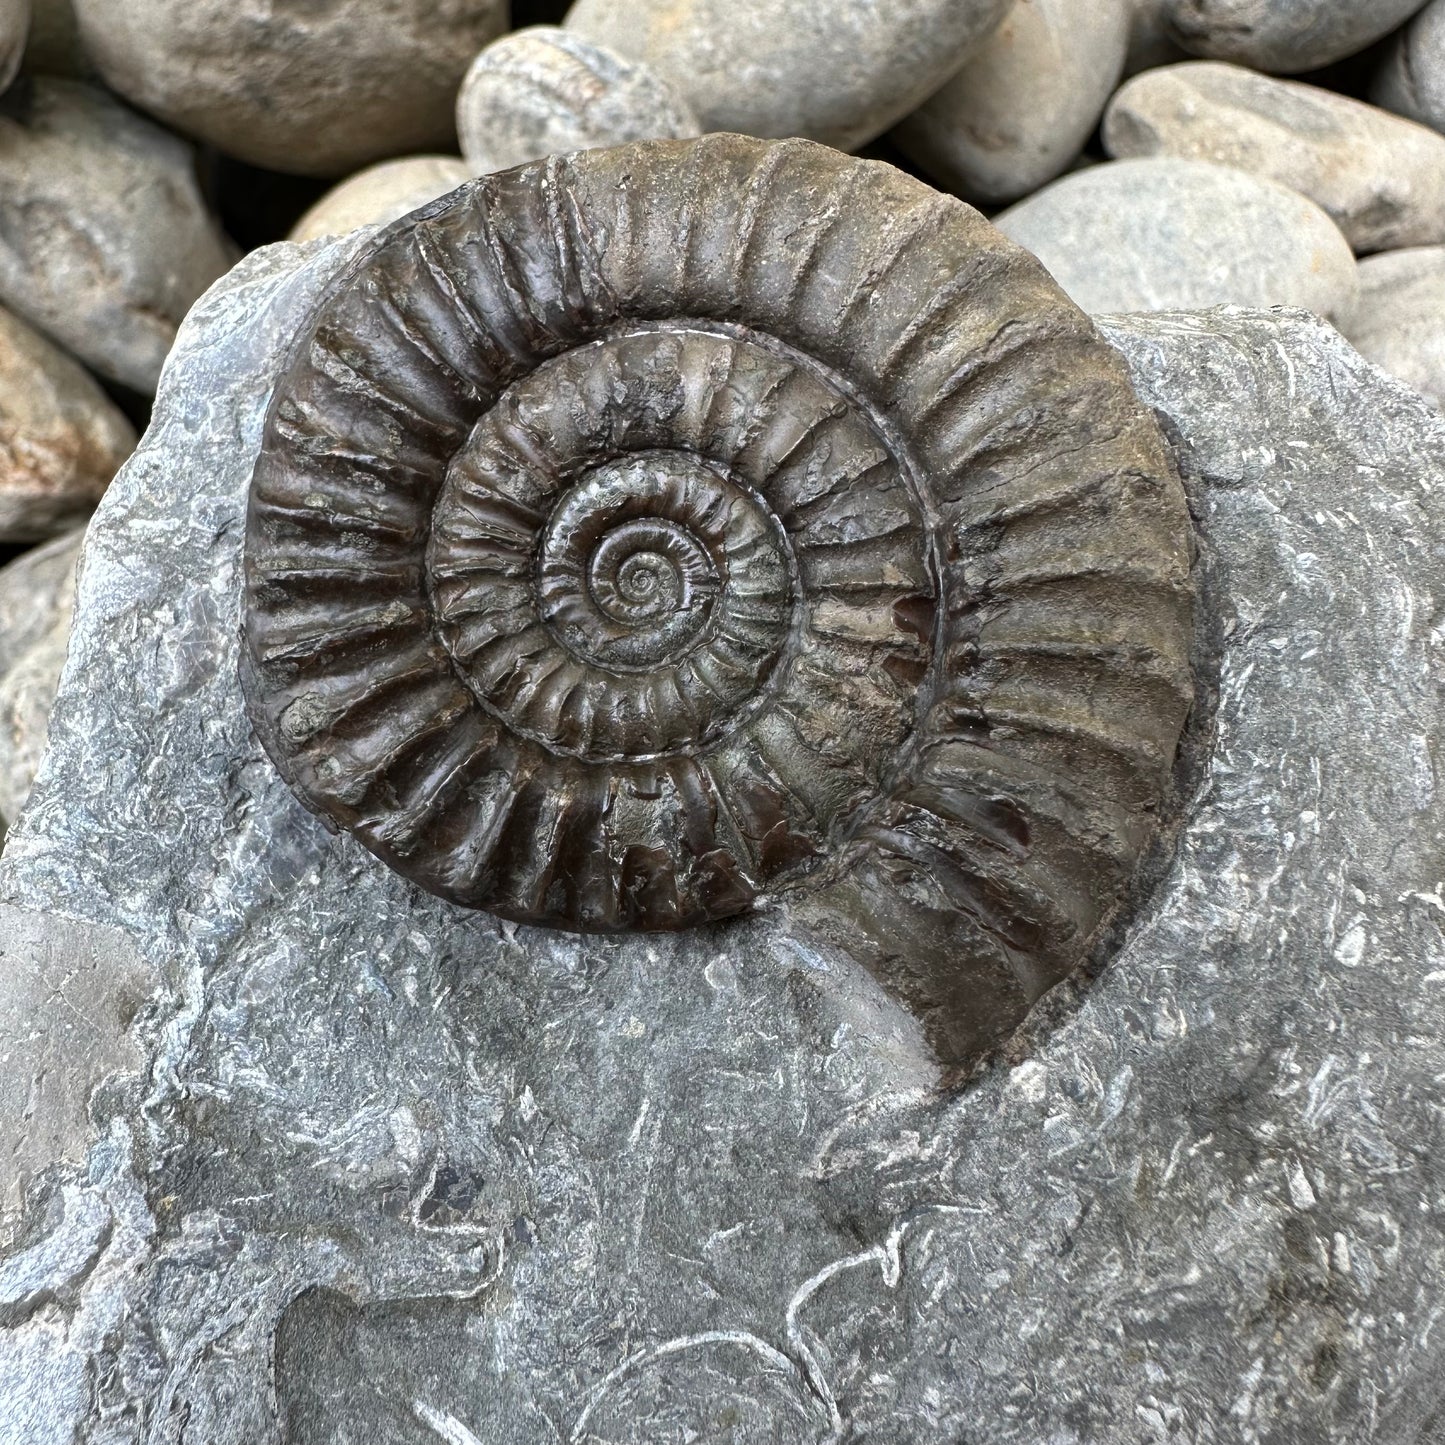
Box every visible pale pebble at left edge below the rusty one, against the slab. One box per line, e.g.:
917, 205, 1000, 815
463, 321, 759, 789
0, 527, 85, 828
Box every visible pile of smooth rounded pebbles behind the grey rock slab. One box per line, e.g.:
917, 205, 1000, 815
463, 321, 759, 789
0, 0, 1445, 827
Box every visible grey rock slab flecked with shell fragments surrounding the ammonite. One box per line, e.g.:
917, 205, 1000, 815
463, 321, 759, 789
0, 222, 1445, 1445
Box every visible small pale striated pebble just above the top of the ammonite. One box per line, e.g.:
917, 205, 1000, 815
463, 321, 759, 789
457, 25, 702, 175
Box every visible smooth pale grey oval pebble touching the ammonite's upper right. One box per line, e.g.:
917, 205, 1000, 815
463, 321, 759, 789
994, 159, 1357, 316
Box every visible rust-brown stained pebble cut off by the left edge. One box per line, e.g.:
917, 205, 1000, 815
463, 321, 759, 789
0, 306, 136, 542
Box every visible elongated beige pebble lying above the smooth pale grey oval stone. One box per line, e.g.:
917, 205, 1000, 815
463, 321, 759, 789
1104, 61, 1445, 251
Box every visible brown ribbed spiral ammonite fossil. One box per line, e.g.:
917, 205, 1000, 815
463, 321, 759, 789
243, 136, 1192, 947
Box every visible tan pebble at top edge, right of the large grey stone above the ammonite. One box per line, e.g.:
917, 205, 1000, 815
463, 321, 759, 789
893, 0, 1131, 204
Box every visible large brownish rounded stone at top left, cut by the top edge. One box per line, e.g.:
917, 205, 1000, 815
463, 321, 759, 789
75, 0, 507, 175
